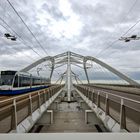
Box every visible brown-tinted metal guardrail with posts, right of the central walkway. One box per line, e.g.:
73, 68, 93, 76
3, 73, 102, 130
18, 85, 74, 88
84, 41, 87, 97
75, 85, 140, 132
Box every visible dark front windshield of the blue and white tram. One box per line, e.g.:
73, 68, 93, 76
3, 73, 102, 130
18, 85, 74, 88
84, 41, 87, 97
0, 71, 16, 85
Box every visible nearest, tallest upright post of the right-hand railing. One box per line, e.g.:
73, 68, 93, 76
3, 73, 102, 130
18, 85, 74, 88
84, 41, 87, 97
120, 98, 126, 129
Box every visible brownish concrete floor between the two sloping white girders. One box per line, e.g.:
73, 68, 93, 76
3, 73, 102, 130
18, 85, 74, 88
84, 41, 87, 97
29, 94, 106, 133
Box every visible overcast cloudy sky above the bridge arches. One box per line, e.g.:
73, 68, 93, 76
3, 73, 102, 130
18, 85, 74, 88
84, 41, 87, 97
0, 0, 140, 79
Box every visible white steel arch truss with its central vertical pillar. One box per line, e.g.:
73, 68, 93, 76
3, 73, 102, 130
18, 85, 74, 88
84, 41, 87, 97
21, 52, 139, 100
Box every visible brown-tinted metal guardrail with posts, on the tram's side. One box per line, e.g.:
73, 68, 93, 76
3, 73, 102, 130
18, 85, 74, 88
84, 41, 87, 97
0, 85, 63, 133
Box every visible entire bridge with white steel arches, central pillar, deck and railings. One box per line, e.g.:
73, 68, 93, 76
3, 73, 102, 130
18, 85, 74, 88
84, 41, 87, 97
0, 51, 140, 133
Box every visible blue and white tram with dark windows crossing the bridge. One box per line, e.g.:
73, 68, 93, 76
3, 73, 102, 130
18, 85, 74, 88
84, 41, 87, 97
0, 70, 50, 95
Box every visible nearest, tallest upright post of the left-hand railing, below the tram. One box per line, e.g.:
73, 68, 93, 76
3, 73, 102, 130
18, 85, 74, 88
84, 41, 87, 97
11, 99, 17, 131
